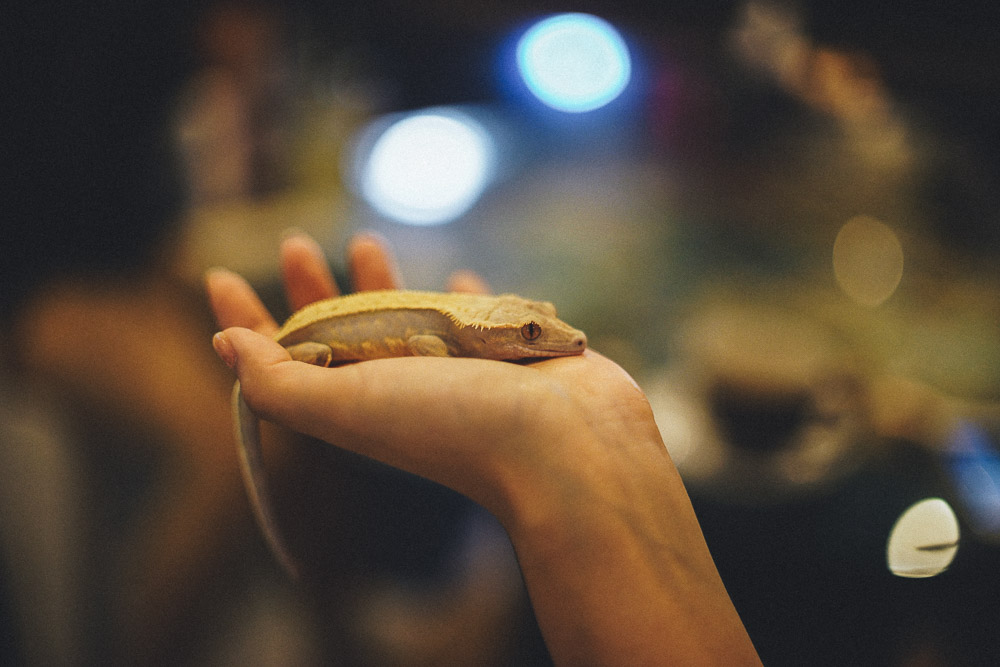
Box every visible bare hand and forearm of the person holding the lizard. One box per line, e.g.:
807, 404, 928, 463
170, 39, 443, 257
207, 236, 760, 665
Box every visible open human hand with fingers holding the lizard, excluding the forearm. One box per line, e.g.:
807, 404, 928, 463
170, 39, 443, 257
207, 235, 658, 511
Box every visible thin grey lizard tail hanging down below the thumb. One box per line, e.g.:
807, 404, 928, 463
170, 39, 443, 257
232, 381, 301, 580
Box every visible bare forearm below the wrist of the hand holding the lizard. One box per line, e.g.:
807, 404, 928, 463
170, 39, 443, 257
496, 434, 759, 665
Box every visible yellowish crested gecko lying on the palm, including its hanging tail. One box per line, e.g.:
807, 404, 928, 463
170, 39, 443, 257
232, 290, 587, 578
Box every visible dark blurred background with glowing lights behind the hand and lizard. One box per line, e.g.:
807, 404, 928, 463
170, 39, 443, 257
0, 0, 1000, 665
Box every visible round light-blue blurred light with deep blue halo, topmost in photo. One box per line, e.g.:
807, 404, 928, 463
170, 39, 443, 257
516, 13, 632, 113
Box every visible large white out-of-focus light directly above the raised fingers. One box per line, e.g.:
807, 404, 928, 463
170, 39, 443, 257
358, 109, 496, 225
